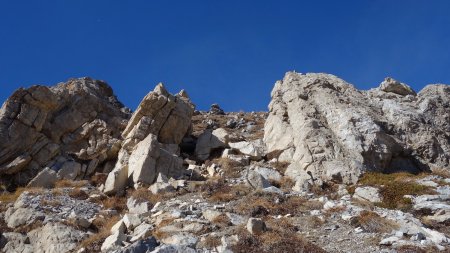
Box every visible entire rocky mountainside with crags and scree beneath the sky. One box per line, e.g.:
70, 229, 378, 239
0, 72, 450, 253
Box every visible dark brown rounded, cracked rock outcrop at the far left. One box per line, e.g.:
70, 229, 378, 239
0, 78, 130, 185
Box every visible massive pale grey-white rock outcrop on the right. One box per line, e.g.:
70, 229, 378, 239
264, 72, 450, 183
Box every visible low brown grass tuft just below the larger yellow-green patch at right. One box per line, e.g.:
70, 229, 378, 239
351, 210, 398, 233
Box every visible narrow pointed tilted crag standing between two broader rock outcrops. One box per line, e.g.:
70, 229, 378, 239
104, 84, 194, 194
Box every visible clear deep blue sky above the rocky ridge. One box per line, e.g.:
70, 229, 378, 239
0, 0, 450, 111
